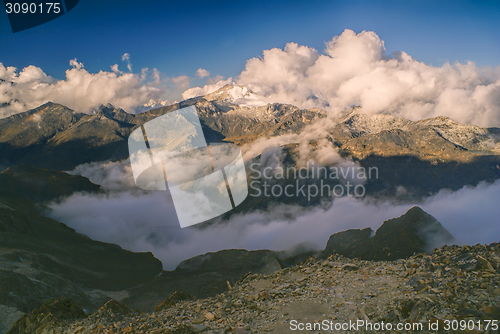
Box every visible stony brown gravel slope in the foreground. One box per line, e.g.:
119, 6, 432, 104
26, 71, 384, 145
9, 243, 500, 334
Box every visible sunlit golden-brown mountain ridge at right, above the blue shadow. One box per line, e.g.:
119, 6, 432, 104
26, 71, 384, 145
330, 108, 500, 162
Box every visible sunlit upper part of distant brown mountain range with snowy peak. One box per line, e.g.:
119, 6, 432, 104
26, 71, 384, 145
0, 85, 500, 166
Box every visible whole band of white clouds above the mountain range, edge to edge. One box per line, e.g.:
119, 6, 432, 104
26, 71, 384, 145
0, 30, 500, 126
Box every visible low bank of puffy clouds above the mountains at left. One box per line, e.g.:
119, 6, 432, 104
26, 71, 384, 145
0, 59, 189, 118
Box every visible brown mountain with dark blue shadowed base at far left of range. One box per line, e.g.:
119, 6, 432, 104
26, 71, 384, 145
0, 102, 135, 170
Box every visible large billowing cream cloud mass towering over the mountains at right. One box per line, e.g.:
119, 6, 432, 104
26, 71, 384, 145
188, 29, 500, 126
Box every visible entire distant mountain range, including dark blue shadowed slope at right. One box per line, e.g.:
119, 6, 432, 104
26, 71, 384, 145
0, 85, 500, 201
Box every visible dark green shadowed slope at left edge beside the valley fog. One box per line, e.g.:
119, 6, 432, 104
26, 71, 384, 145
0, 165, 162, 333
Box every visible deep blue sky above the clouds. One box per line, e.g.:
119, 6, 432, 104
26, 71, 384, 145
0, 0, 500, 83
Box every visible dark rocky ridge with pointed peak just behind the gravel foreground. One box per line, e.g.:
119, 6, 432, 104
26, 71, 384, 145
122, 207, 456, 312
